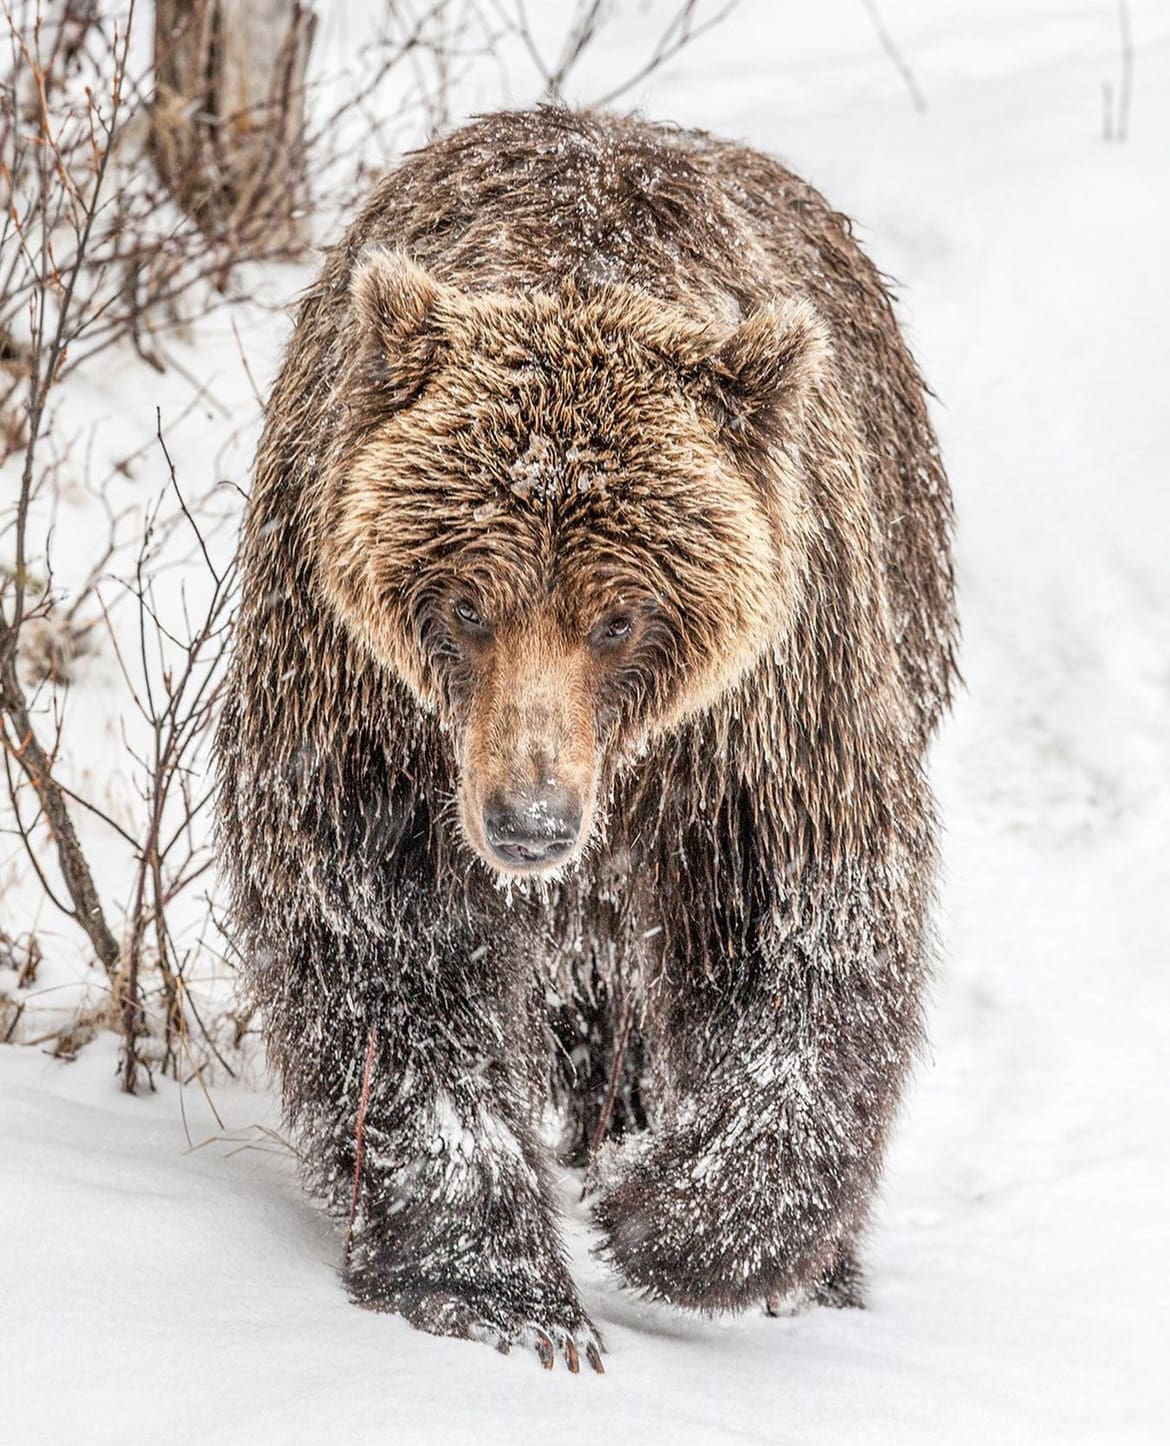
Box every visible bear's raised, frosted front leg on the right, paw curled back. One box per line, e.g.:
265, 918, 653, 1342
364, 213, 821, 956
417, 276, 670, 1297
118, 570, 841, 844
596, 913, 918, 1310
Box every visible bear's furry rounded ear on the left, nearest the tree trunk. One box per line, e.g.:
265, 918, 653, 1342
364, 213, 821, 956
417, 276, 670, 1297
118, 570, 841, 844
350, 250, 451, 405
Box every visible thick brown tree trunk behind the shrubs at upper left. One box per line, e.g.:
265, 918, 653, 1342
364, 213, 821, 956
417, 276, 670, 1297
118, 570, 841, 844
152, 0, 317, 256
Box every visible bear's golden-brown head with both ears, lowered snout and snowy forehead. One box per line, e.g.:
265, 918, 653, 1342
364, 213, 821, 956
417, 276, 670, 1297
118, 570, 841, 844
314, 252, 827, 873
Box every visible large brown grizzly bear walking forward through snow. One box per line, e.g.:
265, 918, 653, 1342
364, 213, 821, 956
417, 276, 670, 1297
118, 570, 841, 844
217, 108, 955, 1369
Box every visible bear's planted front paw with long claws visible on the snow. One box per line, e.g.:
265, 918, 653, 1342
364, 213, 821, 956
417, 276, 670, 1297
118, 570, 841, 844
347, 1265, 605, 1374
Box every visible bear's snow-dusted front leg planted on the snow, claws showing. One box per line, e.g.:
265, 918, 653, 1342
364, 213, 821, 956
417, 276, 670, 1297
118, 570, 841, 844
277, 919, 602, 1371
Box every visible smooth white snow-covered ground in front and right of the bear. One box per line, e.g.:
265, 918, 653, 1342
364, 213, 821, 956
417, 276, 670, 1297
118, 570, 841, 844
0, 0, 1170, 1446
